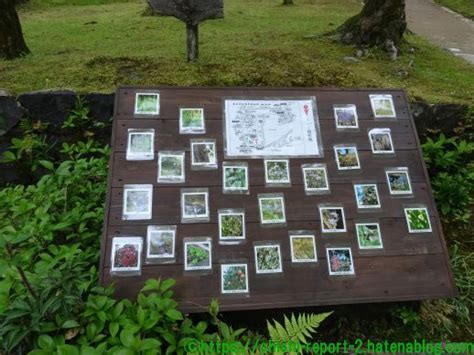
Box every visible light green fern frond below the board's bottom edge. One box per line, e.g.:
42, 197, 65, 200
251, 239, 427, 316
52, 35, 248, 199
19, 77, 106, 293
267, 312, 332, 344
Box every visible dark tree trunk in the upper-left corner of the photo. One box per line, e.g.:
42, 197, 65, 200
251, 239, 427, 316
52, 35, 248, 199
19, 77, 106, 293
0, 0, 30, 59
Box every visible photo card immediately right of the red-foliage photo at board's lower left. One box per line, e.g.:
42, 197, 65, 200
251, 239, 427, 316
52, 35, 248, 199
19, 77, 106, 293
146, 226, 176, 259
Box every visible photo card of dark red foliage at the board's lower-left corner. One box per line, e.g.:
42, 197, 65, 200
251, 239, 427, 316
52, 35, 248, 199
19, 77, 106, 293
110, 237, 143, 273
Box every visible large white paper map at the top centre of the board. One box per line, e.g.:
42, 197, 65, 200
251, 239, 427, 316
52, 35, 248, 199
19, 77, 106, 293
225, 99, 320, 158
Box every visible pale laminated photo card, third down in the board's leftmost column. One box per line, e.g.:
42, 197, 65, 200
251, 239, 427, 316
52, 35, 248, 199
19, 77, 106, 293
122, 185, 153, 220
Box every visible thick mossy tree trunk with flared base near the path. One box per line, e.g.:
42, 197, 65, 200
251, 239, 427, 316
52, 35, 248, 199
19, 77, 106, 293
337, 0, 407, 49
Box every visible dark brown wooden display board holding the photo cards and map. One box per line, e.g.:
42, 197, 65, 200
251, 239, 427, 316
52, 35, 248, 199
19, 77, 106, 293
100, 87, 457, 312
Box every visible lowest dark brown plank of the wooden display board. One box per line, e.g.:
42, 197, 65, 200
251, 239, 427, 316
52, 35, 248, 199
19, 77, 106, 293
104, 254, 454, 312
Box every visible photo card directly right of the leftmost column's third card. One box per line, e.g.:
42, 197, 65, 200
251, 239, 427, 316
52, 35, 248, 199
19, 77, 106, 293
181, 189, 209, 222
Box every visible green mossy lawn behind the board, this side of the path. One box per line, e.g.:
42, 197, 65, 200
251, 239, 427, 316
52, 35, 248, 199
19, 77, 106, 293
0, 0, 474, 103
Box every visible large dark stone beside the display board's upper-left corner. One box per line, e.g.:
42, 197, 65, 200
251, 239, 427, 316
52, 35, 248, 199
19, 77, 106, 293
18, 90, 76, 127
